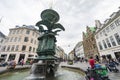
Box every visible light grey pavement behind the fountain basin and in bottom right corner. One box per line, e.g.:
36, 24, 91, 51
60, 62, 120, 80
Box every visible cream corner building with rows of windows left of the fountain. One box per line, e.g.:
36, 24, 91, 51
1, 25, 40, 63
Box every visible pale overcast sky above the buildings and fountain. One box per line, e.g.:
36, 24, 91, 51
0, 0, 120, 53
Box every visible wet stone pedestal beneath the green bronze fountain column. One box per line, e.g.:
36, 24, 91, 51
25, 60, 59, 80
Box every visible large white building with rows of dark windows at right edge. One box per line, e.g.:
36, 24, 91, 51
95, 10, 120, 58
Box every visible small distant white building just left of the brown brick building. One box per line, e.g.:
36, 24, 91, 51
74, 41, 85, 57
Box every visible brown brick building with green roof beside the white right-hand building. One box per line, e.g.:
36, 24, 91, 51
83, 26, 99, 58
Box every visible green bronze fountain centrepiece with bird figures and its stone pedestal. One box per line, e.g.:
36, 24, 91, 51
26, 9, 65, 80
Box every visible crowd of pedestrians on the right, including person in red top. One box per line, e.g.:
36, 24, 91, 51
71, 55, 120, 72
